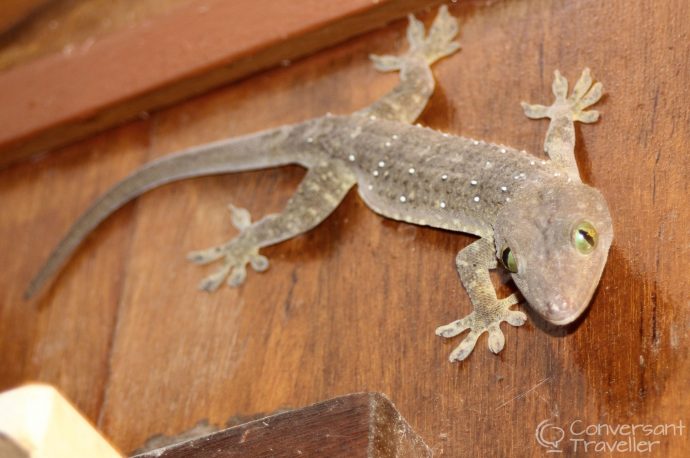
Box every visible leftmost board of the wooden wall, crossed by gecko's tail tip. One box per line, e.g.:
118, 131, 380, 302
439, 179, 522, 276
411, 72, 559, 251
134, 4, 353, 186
0, 123, 148, 421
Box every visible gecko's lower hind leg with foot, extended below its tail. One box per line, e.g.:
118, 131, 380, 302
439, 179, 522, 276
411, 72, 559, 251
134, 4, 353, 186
187, 164, 355, 292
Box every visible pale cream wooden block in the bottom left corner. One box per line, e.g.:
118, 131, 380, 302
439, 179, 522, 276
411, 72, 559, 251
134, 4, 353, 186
0, 384, 122, 458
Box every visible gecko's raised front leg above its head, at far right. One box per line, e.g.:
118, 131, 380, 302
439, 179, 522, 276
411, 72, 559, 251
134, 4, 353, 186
522, 68, 603, 180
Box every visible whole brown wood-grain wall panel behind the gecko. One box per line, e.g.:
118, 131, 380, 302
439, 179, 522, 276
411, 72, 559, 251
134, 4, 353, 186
0, 0, 690, 457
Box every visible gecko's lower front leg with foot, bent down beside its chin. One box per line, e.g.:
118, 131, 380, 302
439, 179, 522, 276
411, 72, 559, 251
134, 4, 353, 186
436, 238, 527, 362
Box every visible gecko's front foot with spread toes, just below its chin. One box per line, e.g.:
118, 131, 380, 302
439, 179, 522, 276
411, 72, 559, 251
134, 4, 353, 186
436, 294, 527, 363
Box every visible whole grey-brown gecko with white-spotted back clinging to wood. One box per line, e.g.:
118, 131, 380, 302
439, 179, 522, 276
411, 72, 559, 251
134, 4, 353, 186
26, 6, 613, 362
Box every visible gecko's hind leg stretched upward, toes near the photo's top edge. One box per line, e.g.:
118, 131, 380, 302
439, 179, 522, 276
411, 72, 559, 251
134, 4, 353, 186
356, 5, 460, 123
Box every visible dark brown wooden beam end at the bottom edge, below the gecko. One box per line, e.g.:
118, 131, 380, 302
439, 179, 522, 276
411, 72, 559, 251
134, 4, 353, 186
133, 393, 432, 458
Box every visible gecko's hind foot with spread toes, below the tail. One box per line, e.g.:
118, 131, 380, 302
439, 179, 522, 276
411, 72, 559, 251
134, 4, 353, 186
187, 205, 268, 292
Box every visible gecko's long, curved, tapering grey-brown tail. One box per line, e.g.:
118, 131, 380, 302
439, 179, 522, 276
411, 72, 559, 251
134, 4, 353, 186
24, 125, 305, 300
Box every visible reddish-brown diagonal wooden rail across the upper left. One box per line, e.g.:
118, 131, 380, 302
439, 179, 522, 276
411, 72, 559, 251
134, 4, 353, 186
0, 0, 435, 165
